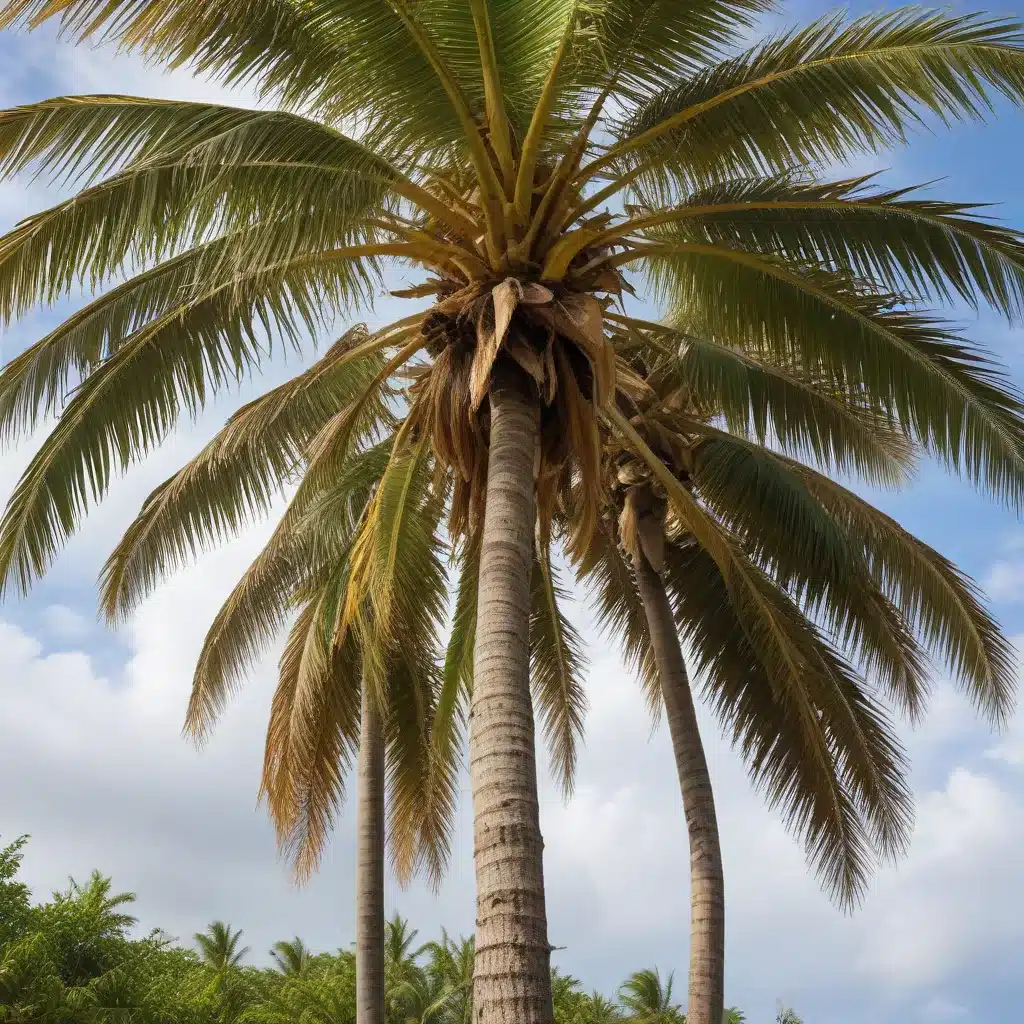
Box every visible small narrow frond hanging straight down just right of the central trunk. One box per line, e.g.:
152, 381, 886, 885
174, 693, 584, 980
529, 546, 587, 800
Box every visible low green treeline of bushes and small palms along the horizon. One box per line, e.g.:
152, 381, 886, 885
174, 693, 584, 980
0, 838, 800, 1024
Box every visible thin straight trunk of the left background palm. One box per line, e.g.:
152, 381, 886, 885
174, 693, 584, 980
355, 684, 384, 1024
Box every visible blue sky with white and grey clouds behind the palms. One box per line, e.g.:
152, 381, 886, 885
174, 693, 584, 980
0, 0, 1024, 1024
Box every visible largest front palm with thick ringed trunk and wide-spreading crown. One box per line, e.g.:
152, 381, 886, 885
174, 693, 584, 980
0, 8, 1024, 1024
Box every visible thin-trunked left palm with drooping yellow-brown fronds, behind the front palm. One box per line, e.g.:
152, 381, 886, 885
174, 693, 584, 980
102, 382, 583, 1024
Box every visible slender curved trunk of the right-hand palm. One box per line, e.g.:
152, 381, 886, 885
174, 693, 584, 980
634, 553, 725, 1024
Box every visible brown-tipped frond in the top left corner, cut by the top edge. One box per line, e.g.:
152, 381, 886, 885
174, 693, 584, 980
0, 0, 467, 151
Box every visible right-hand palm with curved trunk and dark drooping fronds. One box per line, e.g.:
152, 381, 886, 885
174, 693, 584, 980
587, 339, 1015, 1019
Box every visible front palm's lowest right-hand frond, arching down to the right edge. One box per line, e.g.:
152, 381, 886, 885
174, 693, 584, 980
650, 243, 1024, 506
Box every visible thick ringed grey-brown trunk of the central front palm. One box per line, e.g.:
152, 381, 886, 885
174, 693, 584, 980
469, 360, 554, 1024
